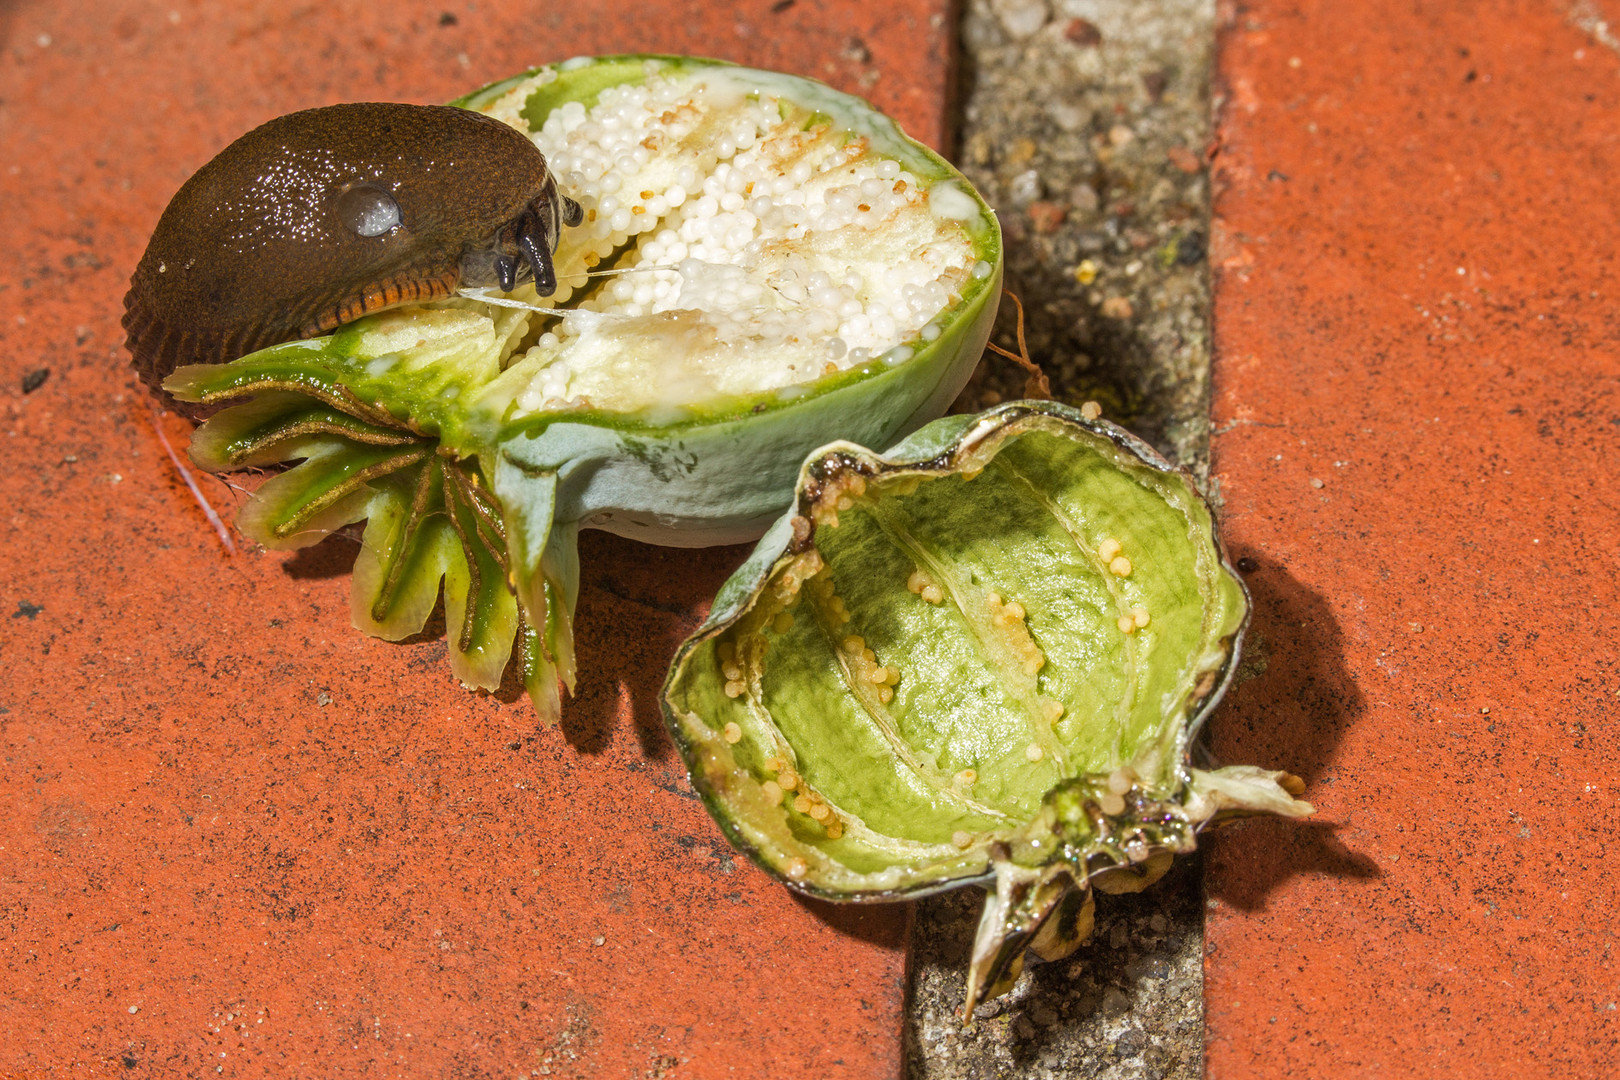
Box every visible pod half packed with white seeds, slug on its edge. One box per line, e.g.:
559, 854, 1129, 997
165, 57, 1001, 717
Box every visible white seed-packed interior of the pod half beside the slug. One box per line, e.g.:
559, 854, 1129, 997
473, 62, 990, 415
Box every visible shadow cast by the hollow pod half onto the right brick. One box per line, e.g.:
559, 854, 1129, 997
1205, 552, 1380, 910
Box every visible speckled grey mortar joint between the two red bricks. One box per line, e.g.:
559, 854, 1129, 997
907, 0, 1213, 1080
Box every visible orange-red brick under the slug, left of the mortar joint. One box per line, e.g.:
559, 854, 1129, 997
0, 0, 949, 1078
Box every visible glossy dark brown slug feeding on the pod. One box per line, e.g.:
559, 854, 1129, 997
123, 102, 580, 396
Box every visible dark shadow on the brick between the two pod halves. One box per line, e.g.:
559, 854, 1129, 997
550, 531, 750, 761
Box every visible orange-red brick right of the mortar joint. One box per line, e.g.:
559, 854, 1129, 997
1205, 0, 1620, 1080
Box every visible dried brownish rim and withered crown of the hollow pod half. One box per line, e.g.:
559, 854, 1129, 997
663, 402, 1311, 1012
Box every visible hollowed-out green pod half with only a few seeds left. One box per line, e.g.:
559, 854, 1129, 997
664, 402, 1311, 1012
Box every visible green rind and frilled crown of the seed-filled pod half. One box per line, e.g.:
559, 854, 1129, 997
165, 57, 1001, 721
